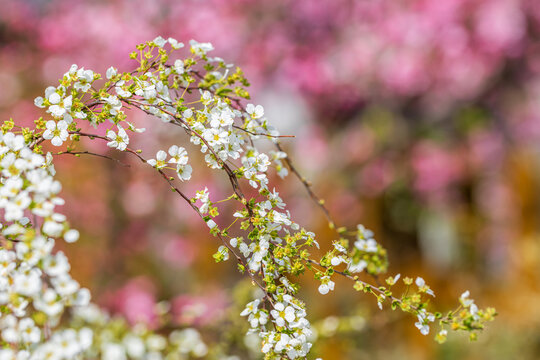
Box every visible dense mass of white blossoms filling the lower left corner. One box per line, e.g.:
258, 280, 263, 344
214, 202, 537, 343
0, 132, 207, 360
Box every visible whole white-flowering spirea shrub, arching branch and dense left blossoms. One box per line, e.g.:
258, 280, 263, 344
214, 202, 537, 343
0, 37, 495, 360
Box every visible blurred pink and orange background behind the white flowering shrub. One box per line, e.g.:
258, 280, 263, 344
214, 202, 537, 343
0, 0, 540, 359
